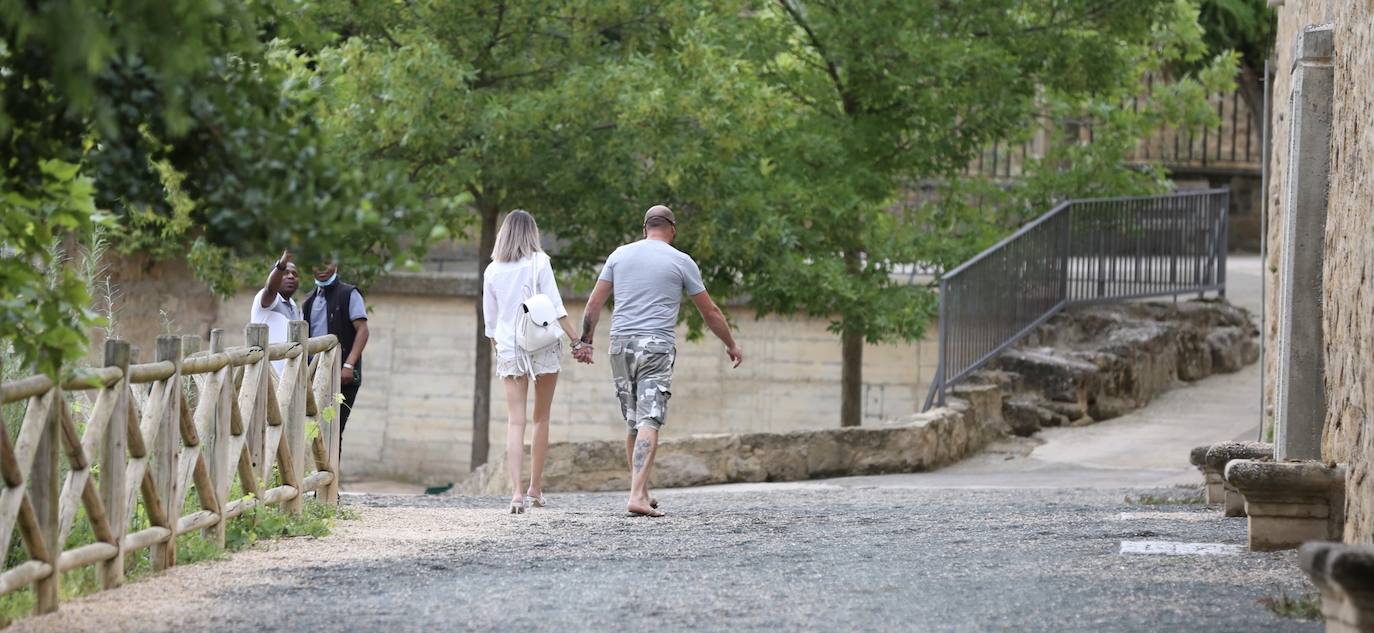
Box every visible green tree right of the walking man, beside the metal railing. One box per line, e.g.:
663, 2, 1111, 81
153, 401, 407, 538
741, 0, 1231, 426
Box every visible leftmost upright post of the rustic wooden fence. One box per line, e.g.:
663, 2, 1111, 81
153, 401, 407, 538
29, 384, 66, 614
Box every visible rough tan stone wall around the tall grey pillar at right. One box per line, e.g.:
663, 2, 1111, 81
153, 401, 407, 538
1264, 0, 1374, 542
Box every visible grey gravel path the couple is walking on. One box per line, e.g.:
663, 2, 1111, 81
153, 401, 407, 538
15, 485, 1320, 632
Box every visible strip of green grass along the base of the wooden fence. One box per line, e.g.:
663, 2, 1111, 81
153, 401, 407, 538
0, 498, 360, 626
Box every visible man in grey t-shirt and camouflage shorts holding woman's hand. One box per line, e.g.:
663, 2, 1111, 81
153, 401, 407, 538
573, 205, 745, 516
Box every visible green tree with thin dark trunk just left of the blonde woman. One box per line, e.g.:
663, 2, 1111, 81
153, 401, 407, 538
311, 0, 791, 467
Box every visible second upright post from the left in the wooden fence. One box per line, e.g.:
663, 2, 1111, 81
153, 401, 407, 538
96, 341, 131, 589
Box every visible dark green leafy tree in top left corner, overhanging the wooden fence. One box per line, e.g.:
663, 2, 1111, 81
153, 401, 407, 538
0, 0, 426, 375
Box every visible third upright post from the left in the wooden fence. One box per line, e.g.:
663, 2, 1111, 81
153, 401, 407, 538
148, 335, 183, 571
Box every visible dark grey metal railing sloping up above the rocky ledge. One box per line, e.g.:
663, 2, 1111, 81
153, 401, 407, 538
925, 189, 1228, 408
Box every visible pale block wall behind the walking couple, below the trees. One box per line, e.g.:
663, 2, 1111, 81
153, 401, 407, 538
216, 275, 936, 483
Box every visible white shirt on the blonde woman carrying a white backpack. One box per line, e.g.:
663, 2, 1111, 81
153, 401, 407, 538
482, 253, 567, 356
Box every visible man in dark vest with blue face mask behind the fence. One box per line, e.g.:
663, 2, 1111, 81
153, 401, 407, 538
301, 254, 368, 437
